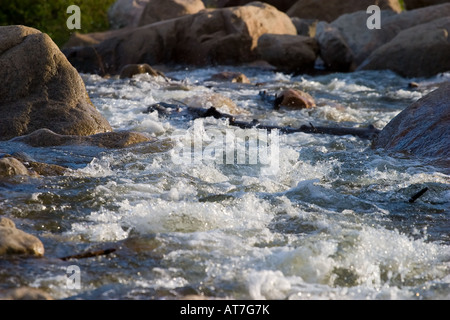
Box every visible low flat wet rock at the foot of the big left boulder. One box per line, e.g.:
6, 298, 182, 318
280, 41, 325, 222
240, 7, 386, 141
12, 129, 152, 149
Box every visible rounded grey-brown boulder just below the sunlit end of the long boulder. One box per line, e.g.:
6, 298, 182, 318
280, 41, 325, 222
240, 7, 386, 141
257, 33, 319, 73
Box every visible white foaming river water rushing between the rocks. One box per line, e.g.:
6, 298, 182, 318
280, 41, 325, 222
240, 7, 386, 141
0, 67, 450, 299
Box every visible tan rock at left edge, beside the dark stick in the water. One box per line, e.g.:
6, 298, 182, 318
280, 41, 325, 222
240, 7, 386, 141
0, 217, 45, 257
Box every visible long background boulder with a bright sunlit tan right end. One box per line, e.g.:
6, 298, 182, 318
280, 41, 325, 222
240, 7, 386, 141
64, 2, 297, 74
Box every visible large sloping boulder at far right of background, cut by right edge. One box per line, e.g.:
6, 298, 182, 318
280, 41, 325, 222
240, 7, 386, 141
358, 17, 450, 77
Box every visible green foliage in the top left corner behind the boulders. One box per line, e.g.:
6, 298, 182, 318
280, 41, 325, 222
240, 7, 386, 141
0, 0, 115, 46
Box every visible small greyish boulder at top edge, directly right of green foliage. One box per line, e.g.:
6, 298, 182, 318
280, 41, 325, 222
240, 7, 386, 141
108, 0, 150, 29
